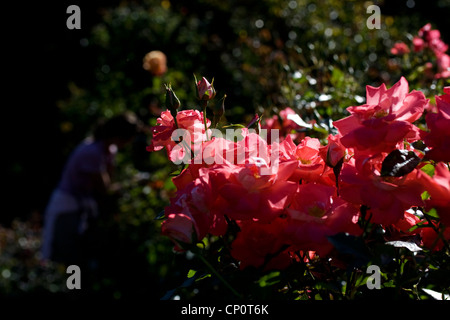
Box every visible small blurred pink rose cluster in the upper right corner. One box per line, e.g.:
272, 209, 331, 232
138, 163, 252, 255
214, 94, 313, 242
391, 23, 450, 79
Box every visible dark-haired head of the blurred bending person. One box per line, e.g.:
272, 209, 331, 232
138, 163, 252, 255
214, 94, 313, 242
94, 111, 140, 149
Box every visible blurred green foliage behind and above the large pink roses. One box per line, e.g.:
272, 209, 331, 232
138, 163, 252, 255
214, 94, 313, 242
59, 0, 444, 147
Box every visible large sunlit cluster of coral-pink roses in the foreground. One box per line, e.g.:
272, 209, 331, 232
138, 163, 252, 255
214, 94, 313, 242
148, 78, 450, 269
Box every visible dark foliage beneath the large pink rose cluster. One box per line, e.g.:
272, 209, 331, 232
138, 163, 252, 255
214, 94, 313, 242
163, 220, 450, 301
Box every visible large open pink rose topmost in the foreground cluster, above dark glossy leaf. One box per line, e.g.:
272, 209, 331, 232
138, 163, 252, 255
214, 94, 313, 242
334, 77, 428, 154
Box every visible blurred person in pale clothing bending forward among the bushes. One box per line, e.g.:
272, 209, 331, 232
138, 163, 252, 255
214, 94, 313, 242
41, 112, 139, 264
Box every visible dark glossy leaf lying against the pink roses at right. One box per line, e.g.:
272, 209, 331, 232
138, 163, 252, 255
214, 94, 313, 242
381, 150, 420, 177
